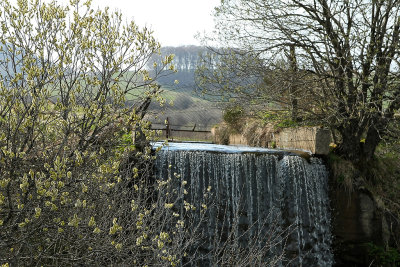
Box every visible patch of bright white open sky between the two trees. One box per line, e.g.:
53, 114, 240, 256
90, 0, 220, 46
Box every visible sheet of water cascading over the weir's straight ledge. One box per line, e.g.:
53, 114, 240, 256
156, 143, 333, 266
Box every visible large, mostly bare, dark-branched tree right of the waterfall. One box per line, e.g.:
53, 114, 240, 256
198, 0, 400, 162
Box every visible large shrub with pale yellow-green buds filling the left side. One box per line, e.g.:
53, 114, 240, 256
0, 0, 174, 266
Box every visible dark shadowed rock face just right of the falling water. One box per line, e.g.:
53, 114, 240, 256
331, 186, 390, 266
